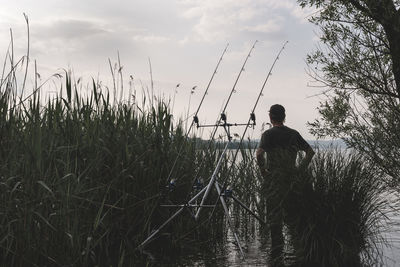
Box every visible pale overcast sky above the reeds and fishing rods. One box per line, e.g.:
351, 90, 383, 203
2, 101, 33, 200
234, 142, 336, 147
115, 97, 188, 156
0, 0, 321, 139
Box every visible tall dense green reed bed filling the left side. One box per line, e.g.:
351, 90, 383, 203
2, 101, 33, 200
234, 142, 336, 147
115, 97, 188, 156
0, 66, 231, 266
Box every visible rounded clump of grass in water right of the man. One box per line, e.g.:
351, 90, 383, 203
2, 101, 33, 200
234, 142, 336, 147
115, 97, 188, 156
284, 149, 388, 266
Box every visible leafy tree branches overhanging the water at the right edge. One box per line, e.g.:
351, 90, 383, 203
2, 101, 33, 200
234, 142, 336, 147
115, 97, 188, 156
298, 0, 400, 185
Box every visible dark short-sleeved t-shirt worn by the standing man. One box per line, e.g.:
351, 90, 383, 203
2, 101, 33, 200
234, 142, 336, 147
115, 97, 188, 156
259, 126, 311, 171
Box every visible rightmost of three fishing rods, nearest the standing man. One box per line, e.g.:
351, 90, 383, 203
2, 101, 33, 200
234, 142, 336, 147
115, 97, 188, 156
209, 41, 288, 223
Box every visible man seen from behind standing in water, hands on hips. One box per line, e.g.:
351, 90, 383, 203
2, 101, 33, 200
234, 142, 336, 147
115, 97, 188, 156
256, 104, 314, 266
